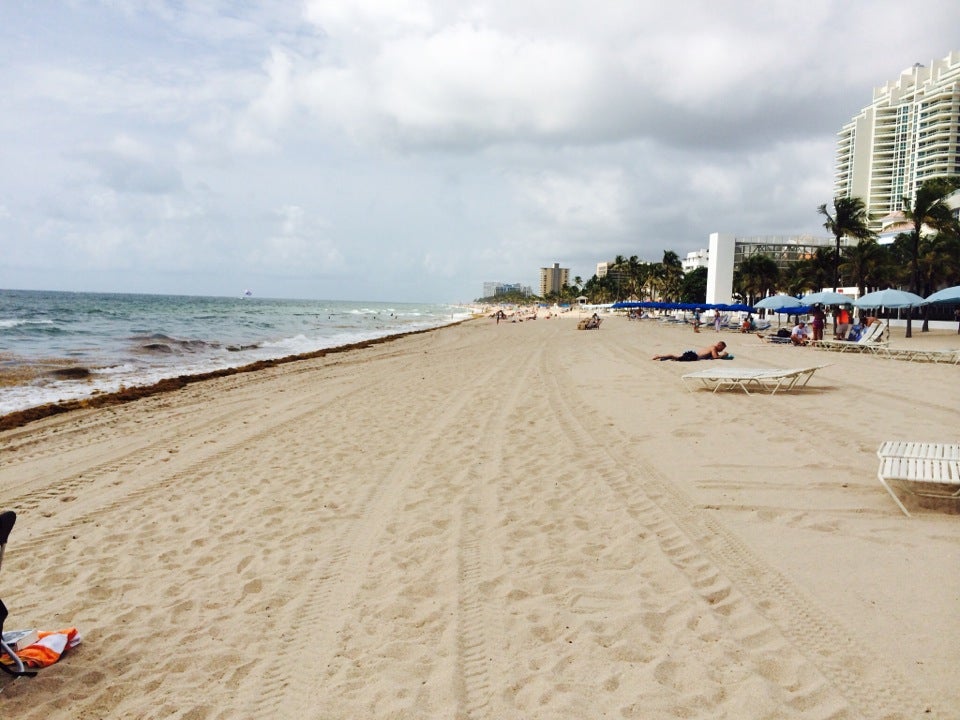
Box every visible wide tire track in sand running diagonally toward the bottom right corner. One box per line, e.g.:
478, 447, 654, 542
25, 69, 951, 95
545, 342, 923, 719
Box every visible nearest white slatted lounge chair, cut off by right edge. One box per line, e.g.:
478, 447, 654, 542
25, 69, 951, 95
877, 441, 960, 517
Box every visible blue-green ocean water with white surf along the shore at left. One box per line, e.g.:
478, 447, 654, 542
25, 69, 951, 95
0, 290, 470, 415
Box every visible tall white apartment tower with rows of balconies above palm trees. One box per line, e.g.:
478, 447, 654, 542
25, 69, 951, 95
834, 51, 960, 231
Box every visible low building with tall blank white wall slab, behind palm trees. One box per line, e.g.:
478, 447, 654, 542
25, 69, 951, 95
701, 233, 855, 303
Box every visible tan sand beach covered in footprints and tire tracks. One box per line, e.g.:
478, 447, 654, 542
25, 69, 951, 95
0, 313, 960, 720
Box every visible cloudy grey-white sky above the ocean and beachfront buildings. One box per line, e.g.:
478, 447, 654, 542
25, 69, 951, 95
0, 0, 960, 302
